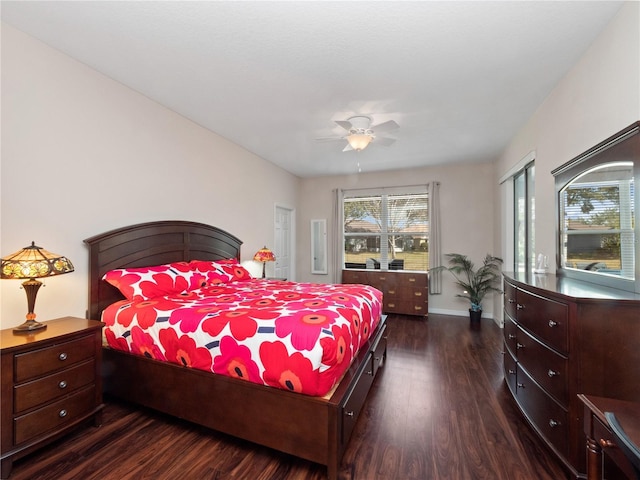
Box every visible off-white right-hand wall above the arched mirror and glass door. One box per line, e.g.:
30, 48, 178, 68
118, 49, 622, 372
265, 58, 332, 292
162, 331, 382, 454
495, 2, 640, 270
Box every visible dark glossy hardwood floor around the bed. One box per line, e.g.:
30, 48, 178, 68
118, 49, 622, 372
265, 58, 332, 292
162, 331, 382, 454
10, 314, 567, 480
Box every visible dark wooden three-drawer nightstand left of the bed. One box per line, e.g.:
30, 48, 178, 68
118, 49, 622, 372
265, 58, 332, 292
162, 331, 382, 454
0, 317, 103, 478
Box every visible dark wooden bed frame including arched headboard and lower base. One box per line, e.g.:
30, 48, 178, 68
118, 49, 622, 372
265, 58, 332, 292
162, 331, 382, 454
85, 221, 387, 480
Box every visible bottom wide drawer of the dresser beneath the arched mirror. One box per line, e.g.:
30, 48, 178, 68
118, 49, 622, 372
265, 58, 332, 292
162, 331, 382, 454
516, 365, 569, 457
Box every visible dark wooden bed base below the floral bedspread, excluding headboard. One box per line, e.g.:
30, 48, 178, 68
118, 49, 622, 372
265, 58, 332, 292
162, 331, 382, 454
103, 317, 387, 480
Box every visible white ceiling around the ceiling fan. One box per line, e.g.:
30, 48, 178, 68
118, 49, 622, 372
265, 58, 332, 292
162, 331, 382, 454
1, 1, 622, 177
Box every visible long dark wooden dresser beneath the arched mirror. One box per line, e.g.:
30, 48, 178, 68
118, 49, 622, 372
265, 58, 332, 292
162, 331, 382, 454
504, 274, 640, 478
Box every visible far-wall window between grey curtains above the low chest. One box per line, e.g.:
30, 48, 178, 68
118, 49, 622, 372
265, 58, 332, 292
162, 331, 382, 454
343, 187, 429, 271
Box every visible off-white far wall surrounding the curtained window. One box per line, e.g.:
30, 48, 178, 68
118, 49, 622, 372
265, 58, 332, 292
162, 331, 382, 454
297, 163, 496, 317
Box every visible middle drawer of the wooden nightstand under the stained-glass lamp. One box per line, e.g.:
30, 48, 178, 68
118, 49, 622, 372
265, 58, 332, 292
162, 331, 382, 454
13, 358, 96, 413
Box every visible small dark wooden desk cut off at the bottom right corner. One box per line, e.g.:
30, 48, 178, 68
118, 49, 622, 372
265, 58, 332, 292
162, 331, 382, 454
578, 395, 640, 480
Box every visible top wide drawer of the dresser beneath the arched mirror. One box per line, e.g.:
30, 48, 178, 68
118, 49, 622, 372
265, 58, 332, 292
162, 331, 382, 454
515, 290, 569, 353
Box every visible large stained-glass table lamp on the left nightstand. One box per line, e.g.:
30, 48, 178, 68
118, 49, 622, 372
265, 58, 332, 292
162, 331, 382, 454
0, 242, 73, 333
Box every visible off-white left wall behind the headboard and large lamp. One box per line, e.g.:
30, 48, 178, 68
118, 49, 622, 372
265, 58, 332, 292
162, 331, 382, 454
0, 24, 299, 328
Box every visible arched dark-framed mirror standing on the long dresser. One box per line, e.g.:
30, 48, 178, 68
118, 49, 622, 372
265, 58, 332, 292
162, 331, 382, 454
552, 122, 640, 292
